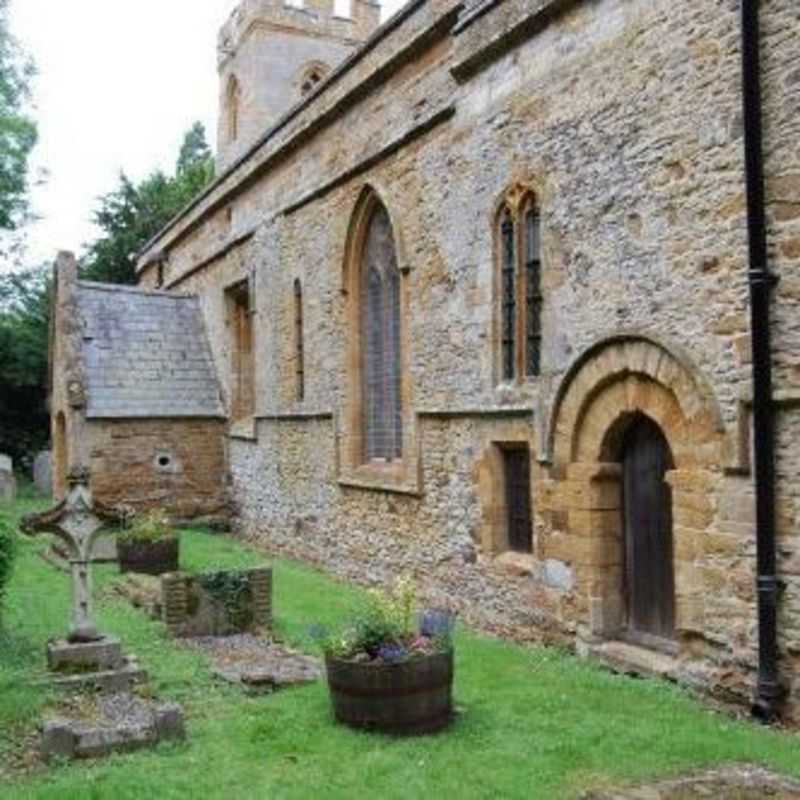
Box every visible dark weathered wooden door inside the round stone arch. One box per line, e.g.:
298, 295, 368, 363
622, 416, 675, 639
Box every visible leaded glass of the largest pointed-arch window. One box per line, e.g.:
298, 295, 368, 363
359, 202, 403, 462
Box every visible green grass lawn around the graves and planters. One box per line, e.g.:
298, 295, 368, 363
0, 488, 800, 800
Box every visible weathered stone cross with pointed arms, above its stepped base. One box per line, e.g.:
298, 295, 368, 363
22, 467, 126, 642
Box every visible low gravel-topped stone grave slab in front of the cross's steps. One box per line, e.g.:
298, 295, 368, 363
41, 692, 186, 759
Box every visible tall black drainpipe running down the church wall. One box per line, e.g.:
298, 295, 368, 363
742, 0, 784, 722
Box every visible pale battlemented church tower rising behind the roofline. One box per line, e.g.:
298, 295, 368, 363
217, 0, 380, 170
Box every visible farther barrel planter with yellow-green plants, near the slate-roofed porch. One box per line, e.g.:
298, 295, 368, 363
117, 508, 180, 575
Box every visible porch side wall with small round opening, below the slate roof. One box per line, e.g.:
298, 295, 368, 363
85, 419, 228, 518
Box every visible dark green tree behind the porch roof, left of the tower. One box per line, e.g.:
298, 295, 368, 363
81, 122, 214, 283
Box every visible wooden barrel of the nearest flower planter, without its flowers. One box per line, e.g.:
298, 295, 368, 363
325, 650, 453, 735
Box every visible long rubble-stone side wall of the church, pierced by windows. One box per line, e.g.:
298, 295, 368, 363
138, 0, 800, 720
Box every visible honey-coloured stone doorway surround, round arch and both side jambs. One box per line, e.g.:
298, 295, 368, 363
544, 332, 726, 649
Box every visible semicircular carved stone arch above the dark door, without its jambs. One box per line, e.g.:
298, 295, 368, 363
545, 333, 725, 470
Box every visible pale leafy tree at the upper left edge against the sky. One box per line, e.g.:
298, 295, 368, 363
0, 0, 37, 231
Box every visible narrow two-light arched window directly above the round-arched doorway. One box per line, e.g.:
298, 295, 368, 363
497, 187, 542, 381
